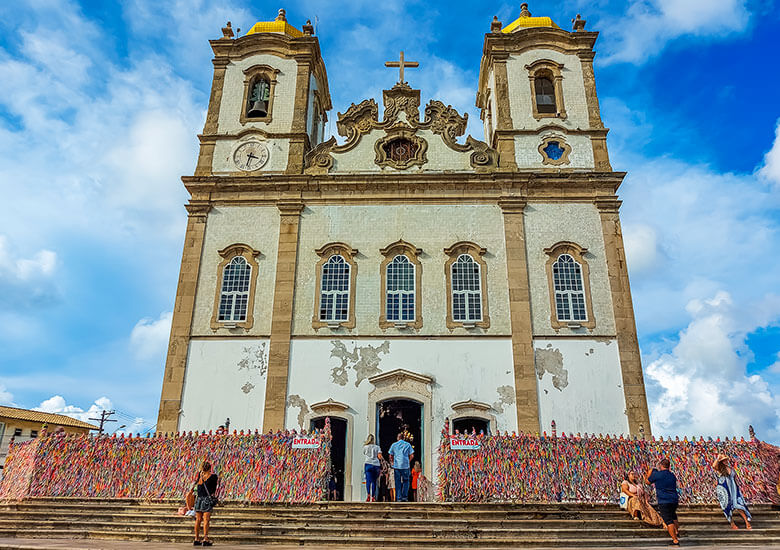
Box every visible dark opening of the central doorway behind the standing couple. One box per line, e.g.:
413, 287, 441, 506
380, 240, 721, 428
376, 399, 425, 466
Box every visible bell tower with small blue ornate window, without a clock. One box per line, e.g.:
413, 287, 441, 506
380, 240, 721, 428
477, 3, 612, 172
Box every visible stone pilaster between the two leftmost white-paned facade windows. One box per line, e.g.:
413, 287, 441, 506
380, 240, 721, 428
263, 200, 303, 431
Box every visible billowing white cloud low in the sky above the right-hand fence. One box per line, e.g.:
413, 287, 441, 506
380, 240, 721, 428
646, 291, 780, 441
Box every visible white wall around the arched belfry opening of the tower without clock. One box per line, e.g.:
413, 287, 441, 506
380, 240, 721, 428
506, 49, 590, 129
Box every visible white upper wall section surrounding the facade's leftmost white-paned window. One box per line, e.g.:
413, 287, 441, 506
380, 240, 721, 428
192, 206, 279, 336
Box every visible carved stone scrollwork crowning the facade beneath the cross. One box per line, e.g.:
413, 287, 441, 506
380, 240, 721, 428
305, 84, 498, 175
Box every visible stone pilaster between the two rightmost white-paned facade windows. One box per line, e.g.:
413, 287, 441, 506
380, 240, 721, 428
498, 197, 539, 433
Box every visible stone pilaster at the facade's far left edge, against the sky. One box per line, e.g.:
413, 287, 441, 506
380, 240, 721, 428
157, 201, 211, 432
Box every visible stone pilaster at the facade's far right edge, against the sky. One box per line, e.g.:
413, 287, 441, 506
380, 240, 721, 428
596, 198, 651, 436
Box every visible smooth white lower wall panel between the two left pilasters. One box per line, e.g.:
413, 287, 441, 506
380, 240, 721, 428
179, 338, 268, 431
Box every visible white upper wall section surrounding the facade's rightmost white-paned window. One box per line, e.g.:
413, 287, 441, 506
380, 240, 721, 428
524, 203, 615, 336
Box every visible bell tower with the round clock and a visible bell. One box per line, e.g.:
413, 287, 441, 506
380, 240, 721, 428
195, 10, 332, 176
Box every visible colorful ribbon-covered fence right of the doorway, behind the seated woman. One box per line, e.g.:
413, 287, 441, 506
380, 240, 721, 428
437, 427, 780, 504
